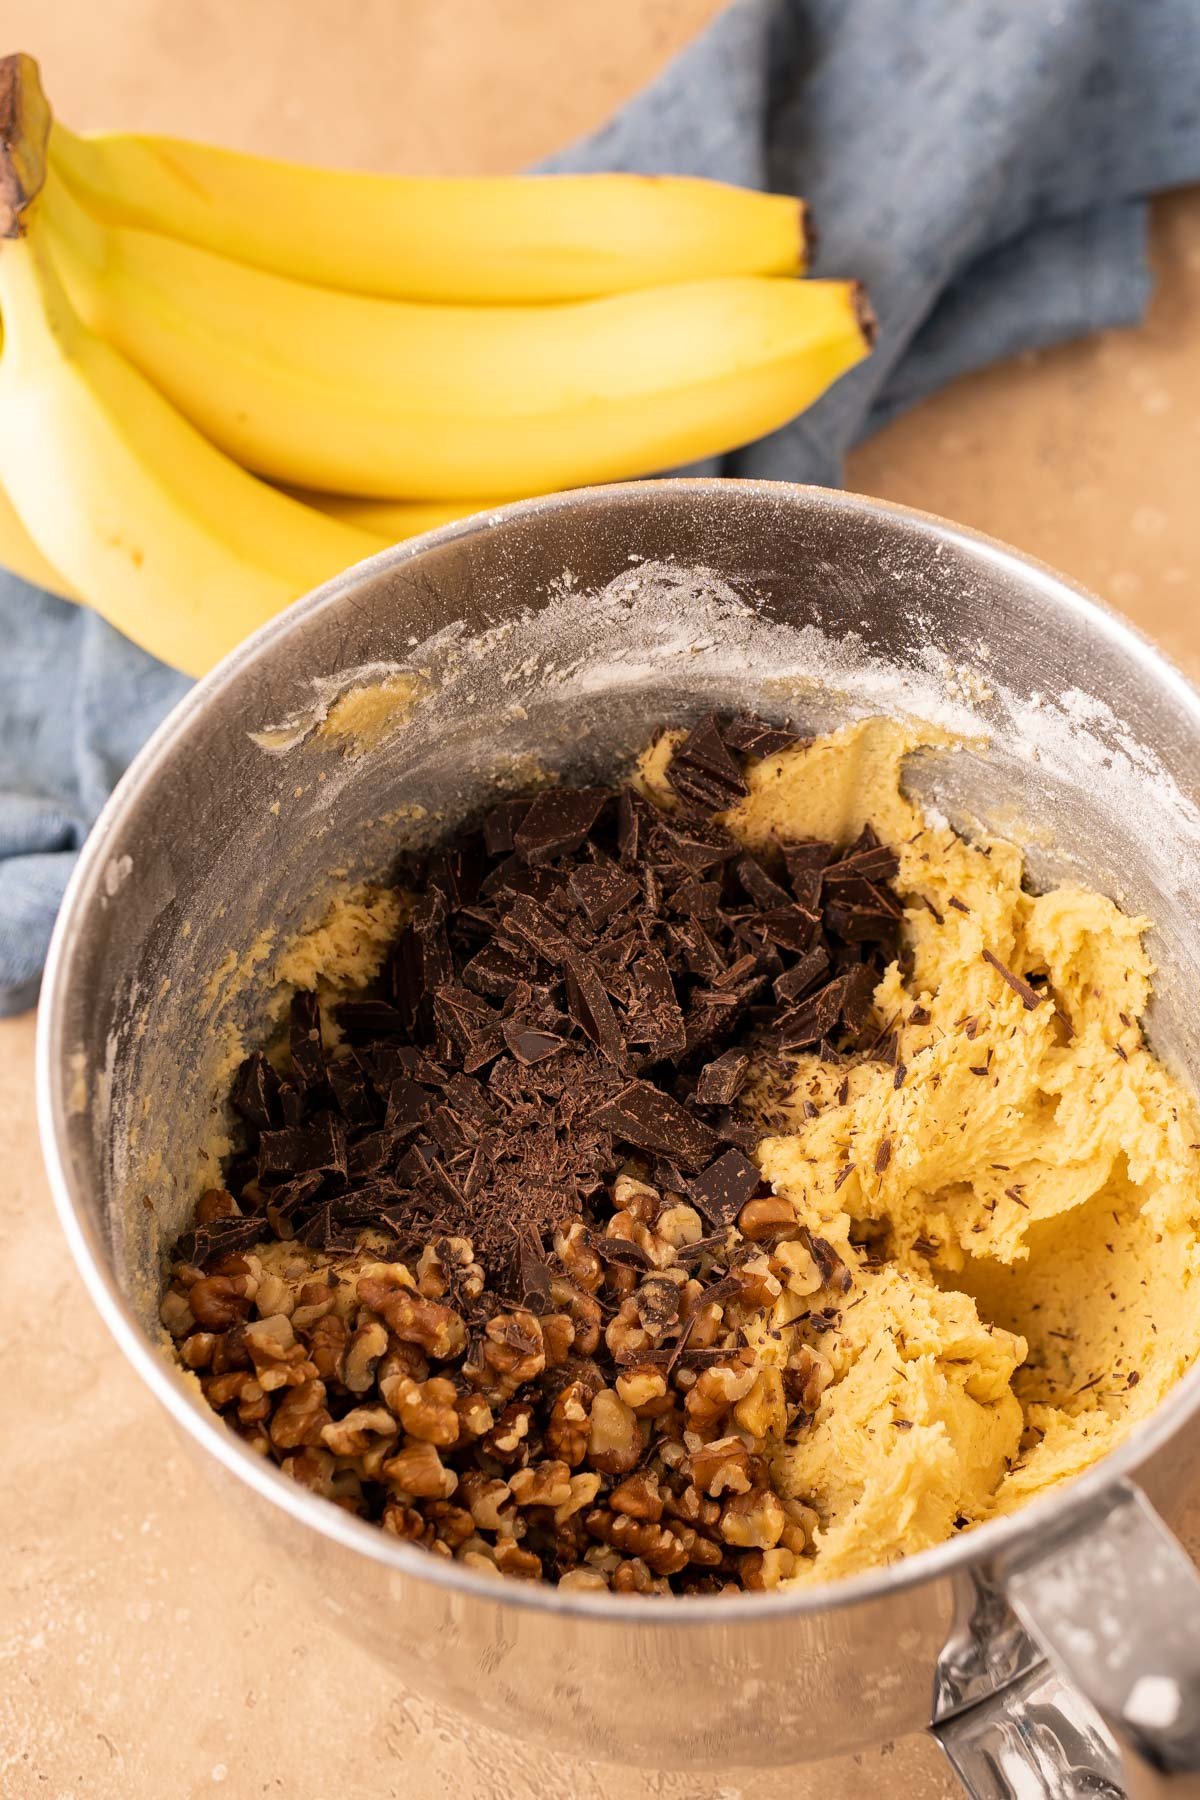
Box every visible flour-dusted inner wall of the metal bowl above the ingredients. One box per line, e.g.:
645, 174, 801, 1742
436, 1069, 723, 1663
39, 482, 1200, 1334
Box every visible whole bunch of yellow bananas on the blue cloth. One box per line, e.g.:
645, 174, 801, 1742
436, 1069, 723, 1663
0, 56, 871, 673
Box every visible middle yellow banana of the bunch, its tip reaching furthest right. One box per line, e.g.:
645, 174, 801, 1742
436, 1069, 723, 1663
43, 171, 869, 500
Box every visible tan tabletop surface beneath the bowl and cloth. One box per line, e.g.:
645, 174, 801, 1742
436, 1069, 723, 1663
0, 0, 1200, 1800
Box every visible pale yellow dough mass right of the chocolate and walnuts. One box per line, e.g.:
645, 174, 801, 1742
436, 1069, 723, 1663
676, 720, 1200, 1580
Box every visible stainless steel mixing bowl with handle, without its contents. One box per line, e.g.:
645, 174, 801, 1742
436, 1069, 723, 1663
40, 481, 1200, 1795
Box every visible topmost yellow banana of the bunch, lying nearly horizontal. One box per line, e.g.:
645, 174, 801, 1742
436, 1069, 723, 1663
50, 122, 806, 302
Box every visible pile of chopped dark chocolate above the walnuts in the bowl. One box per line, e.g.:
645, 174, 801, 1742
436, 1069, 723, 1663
176, 716, 901, 1310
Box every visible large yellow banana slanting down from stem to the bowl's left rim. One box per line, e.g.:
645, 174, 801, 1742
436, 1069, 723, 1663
0, 207, 380, 675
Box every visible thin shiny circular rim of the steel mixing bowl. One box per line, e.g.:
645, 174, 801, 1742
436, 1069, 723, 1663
36, 477, 1200, 1627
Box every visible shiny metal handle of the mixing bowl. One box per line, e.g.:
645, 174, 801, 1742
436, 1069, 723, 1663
934, 1481, 1200, 1800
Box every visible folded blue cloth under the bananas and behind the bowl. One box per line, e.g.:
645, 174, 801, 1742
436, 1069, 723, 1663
0, 0, 1200, 1012
